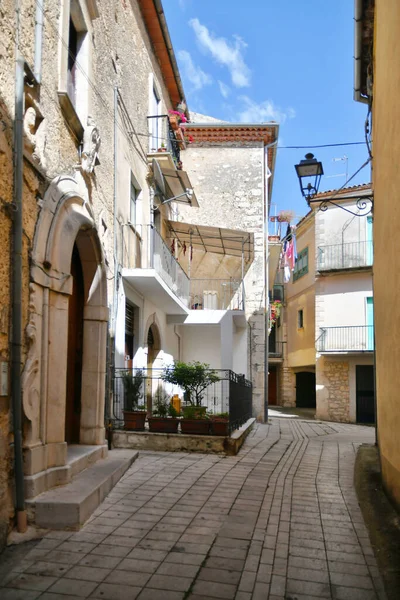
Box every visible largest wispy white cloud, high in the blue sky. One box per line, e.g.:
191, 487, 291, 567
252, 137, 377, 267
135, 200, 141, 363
189, 19, 250, 87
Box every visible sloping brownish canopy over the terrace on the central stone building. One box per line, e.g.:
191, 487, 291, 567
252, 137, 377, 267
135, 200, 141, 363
168, 221, 254, 261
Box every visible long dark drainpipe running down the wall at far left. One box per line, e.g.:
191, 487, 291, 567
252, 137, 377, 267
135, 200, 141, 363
11, 1, 27, 533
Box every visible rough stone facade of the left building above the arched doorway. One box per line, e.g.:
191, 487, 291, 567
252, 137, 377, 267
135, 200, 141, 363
0, 0, 180, 550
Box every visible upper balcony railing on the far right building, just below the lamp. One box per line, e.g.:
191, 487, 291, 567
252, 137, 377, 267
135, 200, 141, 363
317, 241, 373, 271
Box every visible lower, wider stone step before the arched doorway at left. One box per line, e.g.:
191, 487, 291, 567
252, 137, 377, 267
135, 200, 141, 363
27, 450, 139, 530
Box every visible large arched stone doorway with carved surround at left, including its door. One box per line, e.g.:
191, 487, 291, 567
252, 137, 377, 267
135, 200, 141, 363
23, 176, 108, 497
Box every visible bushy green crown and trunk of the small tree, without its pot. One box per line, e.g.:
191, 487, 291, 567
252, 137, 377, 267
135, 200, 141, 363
161, 361, 219, 406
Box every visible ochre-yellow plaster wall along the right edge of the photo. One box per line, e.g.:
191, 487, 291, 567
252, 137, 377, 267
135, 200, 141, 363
373, 0, 400, 505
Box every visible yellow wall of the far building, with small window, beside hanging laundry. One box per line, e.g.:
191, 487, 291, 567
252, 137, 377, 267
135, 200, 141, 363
285, 214, 315, 367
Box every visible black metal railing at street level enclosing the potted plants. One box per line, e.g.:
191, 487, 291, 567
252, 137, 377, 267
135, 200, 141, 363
108, 368, 253, 431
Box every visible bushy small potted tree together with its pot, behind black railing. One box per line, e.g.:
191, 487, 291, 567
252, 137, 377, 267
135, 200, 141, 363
161, 361, 219, 434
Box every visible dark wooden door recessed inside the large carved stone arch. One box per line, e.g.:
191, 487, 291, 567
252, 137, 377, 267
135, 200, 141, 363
65, 244, 85, 444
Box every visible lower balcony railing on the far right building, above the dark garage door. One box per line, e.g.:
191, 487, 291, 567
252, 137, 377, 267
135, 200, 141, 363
316, 325, 374, 352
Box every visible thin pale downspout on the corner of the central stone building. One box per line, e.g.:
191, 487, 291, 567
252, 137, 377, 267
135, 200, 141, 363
263, 139, 278, 423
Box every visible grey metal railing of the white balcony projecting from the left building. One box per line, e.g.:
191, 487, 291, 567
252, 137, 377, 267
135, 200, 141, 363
150, 225, 190, 306
